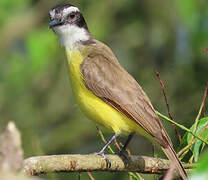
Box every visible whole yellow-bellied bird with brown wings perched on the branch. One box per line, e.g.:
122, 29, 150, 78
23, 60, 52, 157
49, 4, 186, 179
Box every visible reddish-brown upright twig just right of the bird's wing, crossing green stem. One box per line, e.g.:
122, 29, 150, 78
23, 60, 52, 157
155, 70, 181, 143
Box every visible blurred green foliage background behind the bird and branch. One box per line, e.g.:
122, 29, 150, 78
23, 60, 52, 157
0, 0, 208, 179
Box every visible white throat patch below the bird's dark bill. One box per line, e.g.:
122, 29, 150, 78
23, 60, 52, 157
54, 24, 90, 48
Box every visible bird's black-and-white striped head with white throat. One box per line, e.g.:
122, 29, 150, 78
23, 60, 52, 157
48, 4, 91, 47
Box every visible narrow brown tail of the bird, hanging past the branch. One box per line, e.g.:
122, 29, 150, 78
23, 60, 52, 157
162, 145, 187, 180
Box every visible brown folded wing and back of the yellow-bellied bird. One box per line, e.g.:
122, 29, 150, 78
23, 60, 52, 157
80, 41, 167, 146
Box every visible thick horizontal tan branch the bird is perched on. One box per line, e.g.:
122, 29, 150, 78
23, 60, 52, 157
23, 154, 194, 175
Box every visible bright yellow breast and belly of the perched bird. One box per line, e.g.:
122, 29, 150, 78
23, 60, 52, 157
67, 51, 151, 137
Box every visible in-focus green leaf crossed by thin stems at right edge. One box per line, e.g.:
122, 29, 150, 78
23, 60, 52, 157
187, 117, 208, 162
